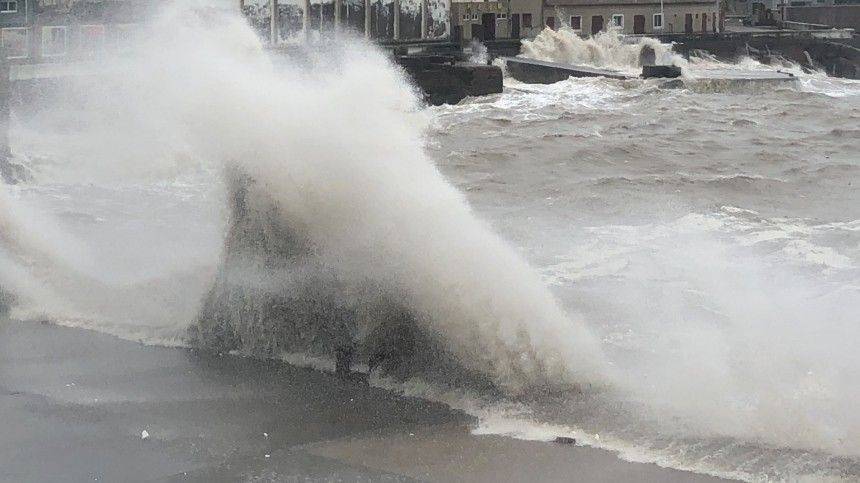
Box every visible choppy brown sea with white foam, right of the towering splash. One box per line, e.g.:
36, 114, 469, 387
418, 70, 860, 481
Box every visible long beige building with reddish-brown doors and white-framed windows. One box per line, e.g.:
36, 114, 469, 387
544, 0, 719, 36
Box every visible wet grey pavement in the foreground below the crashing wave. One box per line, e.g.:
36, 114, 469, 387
0, 321, 728, 482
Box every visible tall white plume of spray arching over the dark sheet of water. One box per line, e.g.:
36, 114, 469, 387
0, 2, 602, 390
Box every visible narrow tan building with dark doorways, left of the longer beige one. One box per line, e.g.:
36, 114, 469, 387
450, 0, 543, 42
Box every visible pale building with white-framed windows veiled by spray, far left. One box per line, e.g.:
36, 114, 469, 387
0, 0, 156, 63
